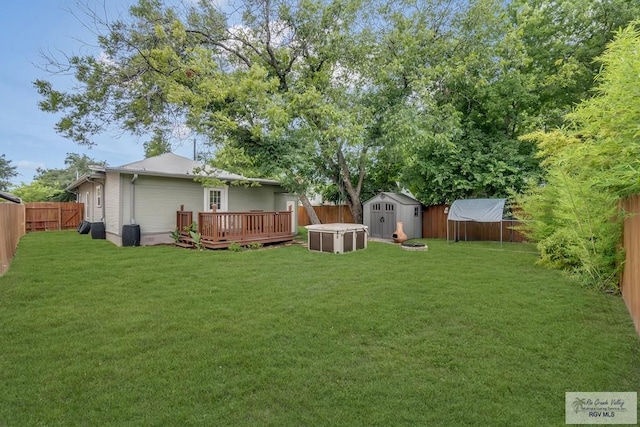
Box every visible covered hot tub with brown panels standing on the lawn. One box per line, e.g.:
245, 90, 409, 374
306, 223, 368, 254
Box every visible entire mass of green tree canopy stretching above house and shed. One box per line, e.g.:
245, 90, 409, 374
35, 0, 640, 220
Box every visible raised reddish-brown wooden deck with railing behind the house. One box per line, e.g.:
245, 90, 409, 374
176, 210, 293, 249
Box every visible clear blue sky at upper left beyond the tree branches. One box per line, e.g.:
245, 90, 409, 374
0, 0, 193, 185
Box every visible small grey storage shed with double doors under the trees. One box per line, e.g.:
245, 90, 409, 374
362, 192, 422, 239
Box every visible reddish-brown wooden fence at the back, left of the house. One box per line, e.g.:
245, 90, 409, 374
26, 202, 84, 232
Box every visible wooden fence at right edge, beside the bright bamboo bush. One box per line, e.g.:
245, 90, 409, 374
620, 195, 640, 334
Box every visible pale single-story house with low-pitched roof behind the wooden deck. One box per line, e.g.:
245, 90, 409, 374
67, 153, 298, 246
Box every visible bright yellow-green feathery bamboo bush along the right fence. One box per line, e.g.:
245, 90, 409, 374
517, 24, 640, 291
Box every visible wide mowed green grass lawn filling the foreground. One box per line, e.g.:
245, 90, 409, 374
0, 232, 640, 426
